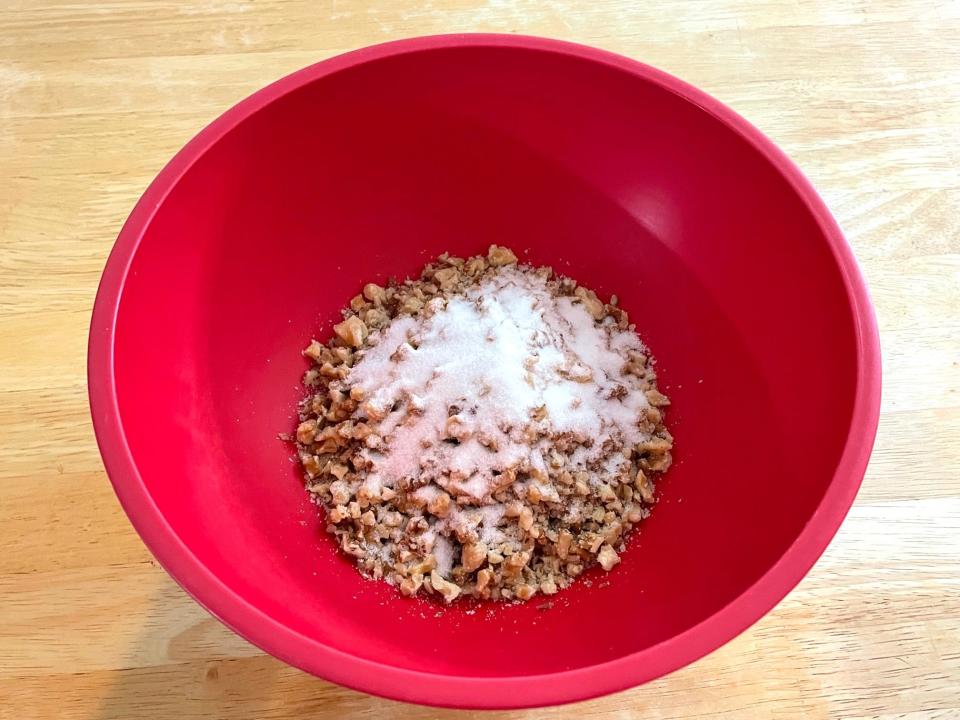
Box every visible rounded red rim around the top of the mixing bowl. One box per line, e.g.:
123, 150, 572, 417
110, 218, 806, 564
87, 34, 881, 708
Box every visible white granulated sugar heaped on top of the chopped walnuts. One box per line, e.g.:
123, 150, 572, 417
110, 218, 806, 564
348, 269, 647, 498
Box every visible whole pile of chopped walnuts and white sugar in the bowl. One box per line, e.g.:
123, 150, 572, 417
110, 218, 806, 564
296, 246, 673, 602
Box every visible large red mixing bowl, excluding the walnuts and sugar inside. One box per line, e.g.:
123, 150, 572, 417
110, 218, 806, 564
89, 35, 880, 707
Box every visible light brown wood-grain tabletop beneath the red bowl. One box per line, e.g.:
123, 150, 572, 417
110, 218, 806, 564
0, 0, 960, 720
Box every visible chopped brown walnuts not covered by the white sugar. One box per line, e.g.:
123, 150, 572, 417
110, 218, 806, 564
291, 245, 673, 607
